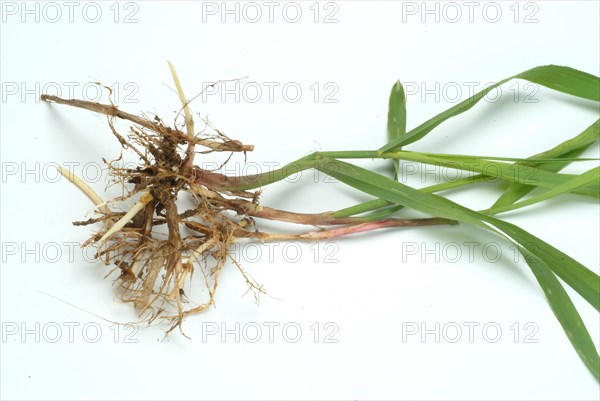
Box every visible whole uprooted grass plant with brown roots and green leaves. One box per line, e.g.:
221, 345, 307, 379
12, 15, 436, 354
42, 64, 600, 380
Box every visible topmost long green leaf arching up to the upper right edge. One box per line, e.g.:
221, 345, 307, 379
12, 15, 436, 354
379, 65, 600, 152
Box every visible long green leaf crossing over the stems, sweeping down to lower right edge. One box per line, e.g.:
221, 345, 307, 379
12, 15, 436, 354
315, 158, 600, 381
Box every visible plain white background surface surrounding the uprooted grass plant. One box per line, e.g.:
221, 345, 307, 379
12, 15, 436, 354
0, 1, 600, 400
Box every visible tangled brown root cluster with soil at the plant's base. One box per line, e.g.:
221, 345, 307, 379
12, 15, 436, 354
42, 95, 264, 332
